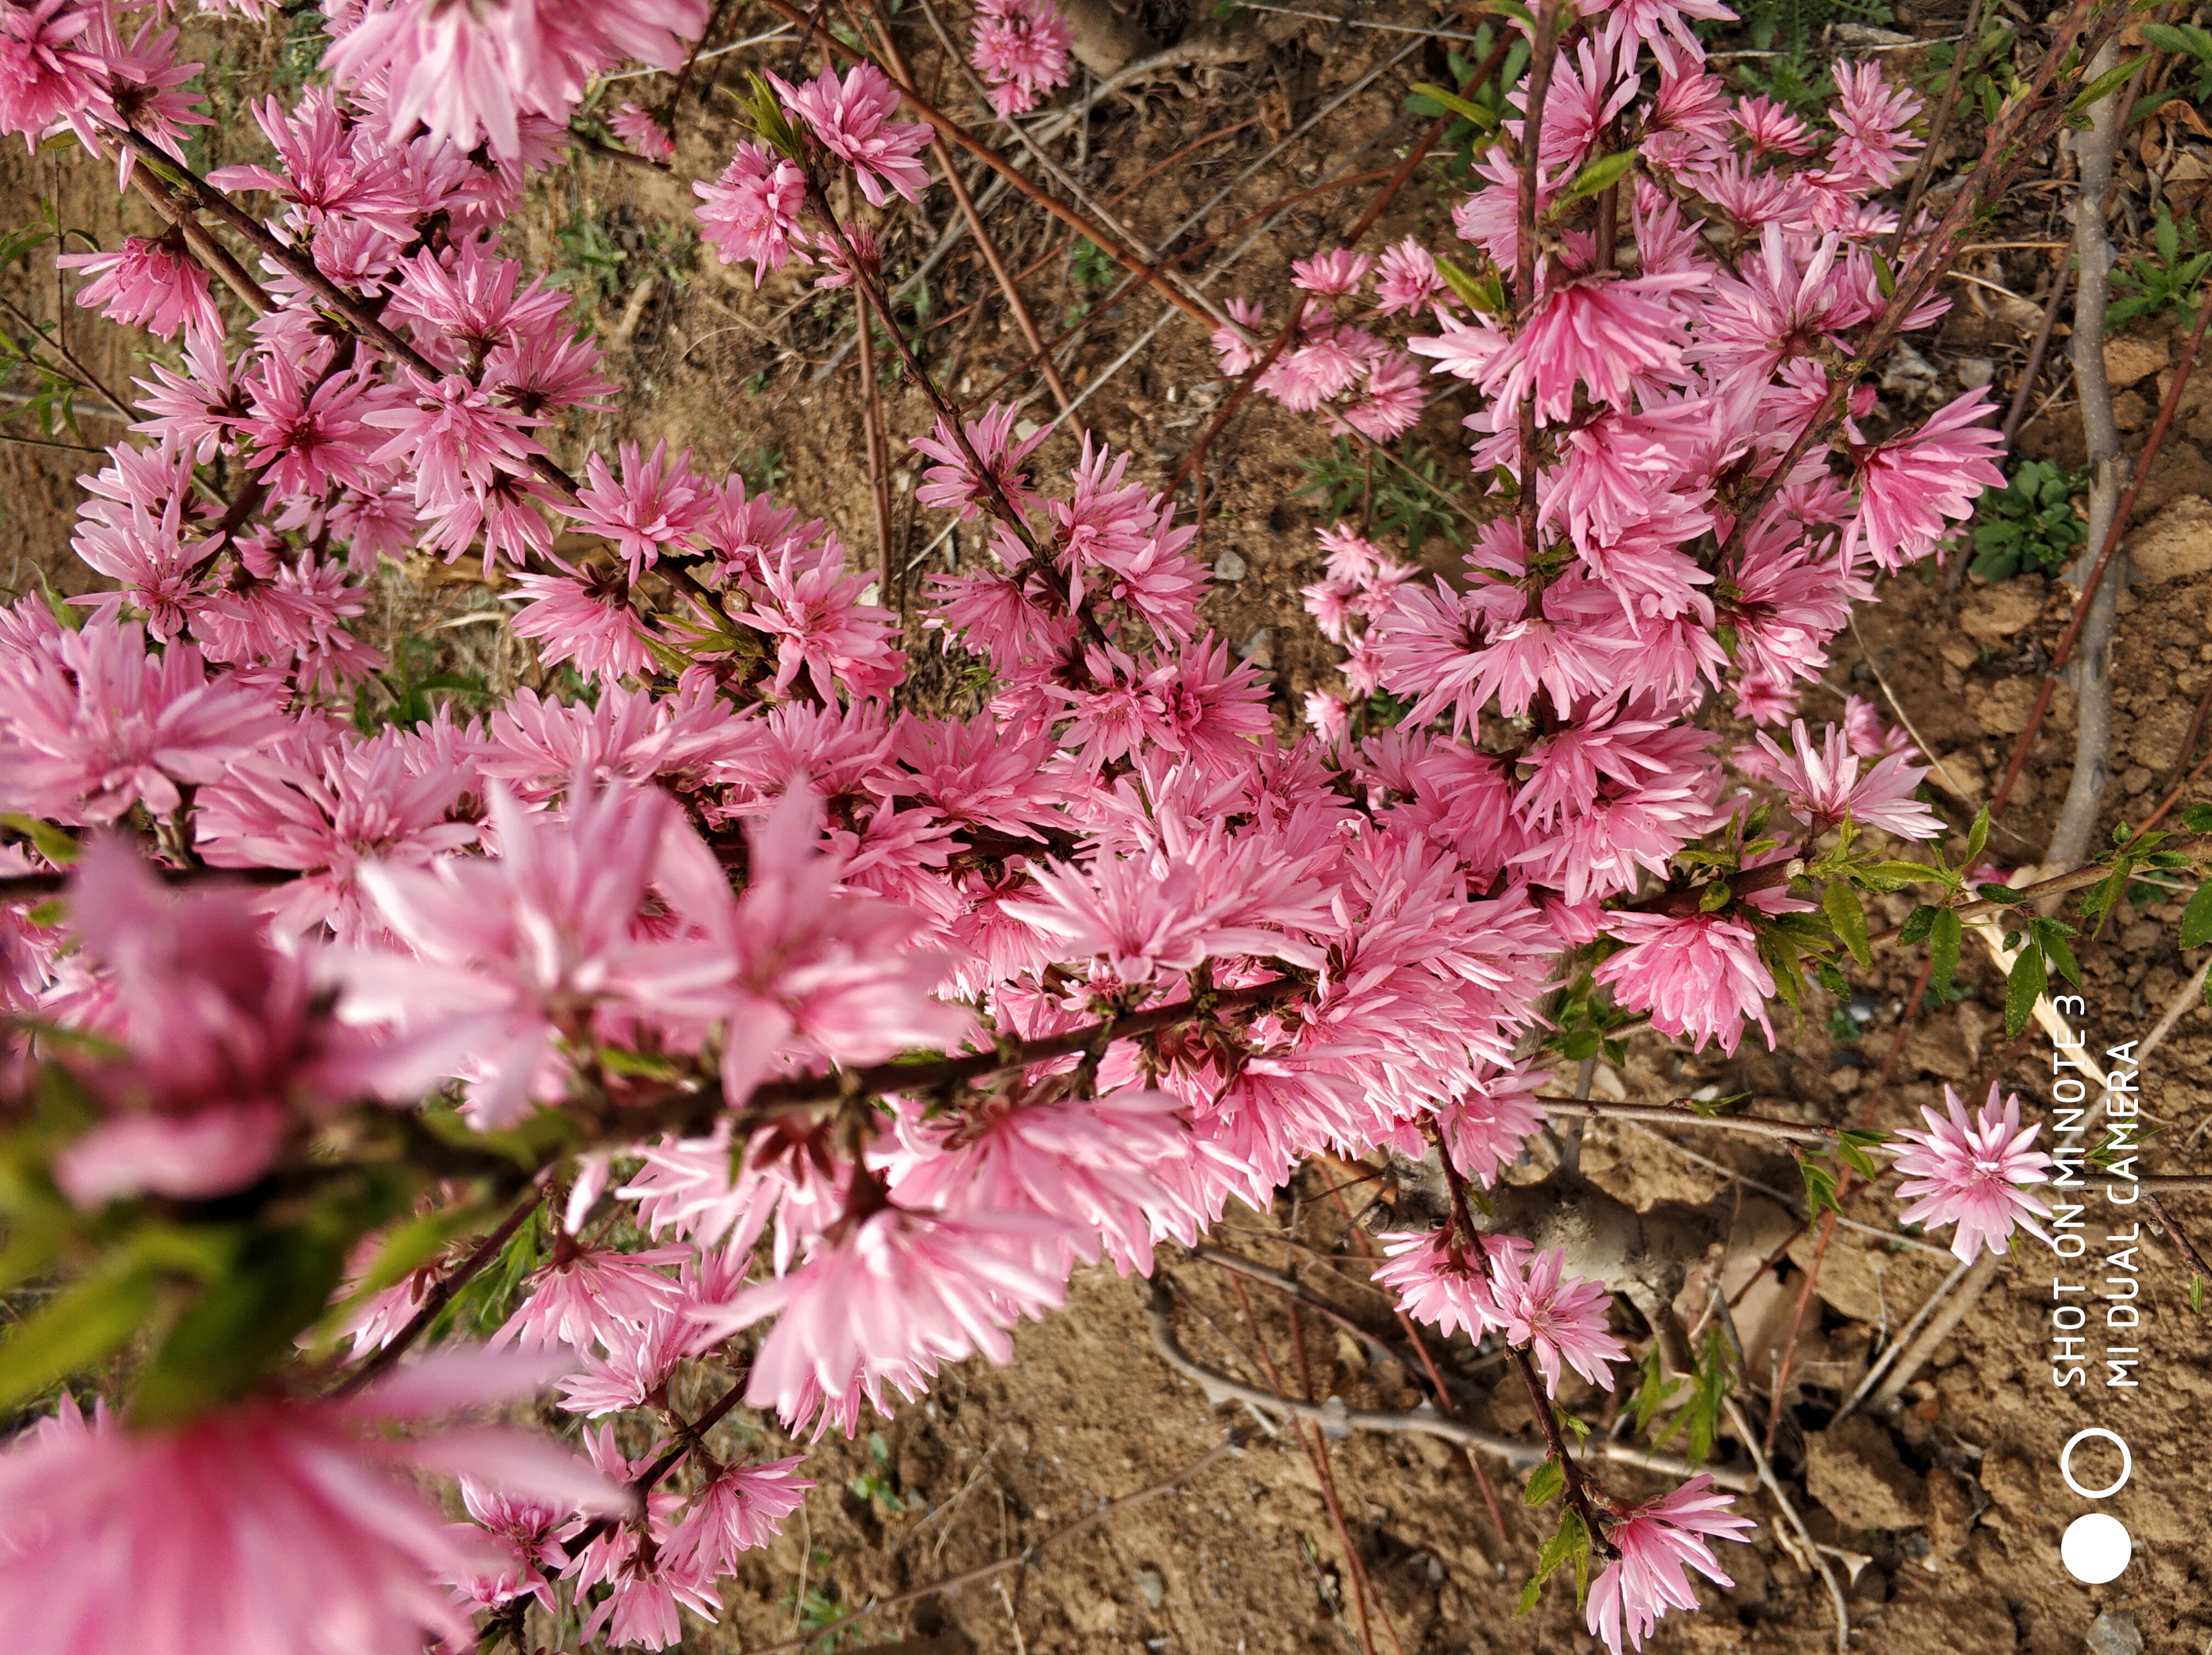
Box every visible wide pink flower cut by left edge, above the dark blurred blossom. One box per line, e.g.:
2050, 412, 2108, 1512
0, 620, 287, 821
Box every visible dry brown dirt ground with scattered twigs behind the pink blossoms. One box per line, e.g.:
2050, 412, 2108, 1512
0, 0, 2212, 1655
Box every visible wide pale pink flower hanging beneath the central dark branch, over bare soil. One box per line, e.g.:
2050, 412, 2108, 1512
699, 1206, 1066, 1436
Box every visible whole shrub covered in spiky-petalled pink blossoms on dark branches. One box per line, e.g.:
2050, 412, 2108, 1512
0, 0, 2117, 1653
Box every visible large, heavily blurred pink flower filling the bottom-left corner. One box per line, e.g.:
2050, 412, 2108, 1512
0, 1352, 630, 1655
